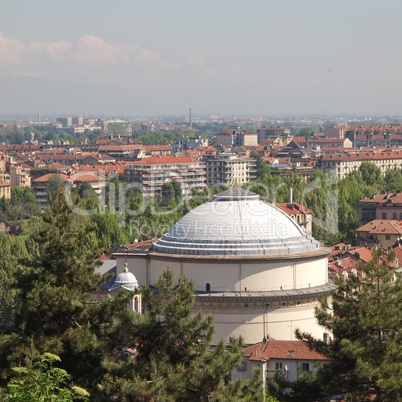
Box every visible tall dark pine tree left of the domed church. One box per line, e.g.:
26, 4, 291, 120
0, 191, 133, 395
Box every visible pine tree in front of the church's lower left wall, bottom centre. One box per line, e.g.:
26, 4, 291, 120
102, 270, 262, 402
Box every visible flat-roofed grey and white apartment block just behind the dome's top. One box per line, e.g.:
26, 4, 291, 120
204, 152, 257, 186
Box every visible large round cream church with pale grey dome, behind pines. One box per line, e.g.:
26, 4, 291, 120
114, 187, 334, 344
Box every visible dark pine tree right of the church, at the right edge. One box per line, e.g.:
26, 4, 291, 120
297, 249, 402, 402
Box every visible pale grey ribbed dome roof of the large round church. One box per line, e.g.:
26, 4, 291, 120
152, 188, 320, 256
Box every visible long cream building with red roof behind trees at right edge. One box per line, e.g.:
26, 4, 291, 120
319, 150, 402, 179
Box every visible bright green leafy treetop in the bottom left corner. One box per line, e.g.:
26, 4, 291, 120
2, 353, 89, 402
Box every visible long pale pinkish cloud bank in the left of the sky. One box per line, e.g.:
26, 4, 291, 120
0, 33, 221, 91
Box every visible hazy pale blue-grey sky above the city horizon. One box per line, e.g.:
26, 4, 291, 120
0, 0, 402, 116
